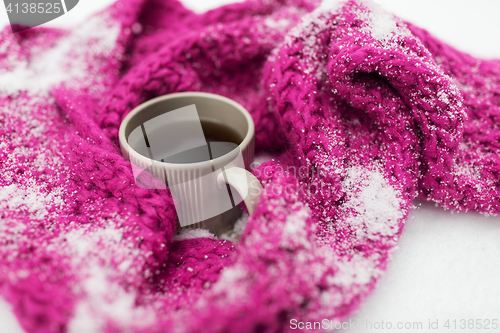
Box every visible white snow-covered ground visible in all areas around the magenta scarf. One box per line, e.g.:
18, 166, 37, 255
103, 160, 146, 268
0, 0, 500, 333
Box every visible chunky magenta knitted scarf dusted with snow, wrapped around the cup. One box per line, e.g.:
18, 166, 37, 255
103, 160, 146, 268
0, 0, 500, 333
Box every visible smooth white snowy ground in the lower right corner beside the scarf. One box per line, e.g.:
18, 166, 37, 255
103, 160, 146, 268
349, 203, 500, 333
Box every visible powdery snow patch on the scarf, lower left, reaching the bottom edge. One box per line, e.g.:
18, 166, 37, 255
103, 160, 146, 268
61, 217, 153, 333
